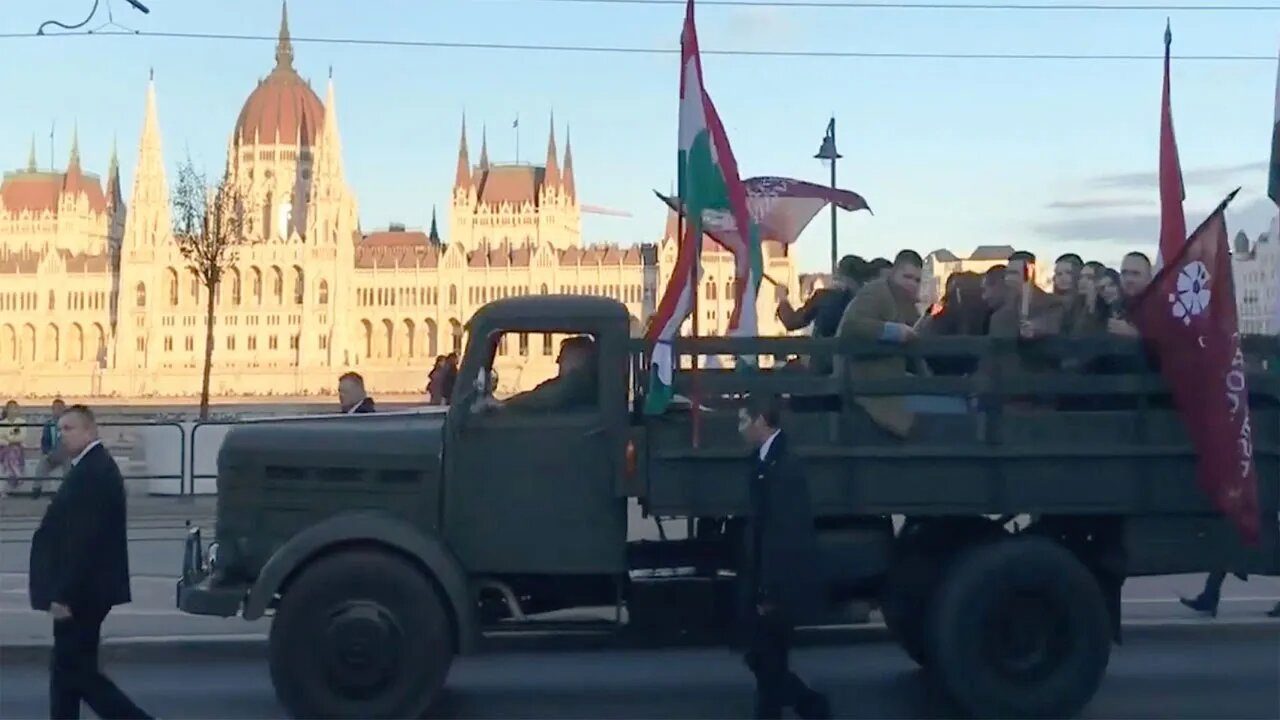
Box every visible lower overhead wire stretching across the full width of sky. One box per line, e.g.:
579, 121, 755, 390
0, 31, 1276, 63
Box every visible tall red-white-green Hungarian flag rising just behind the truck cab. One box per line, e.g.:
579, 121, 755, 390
645, 0, 763, 414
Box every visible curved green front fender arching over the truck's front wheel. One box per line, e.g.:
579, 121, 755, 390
243, 512, 476, 653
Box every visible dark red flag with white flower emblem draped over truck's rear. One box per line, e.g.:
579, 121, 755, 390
1130, 190, 1261, 544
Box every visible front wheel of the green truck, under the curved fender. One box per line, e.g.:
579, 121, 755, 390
269, 550, 454, 717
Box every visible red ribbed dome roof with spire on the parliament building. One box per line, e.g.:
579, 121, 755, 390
236, 2, 324, 146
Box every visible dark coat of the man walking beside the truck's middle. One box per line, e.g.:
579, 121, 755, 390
741, 433, 827, 624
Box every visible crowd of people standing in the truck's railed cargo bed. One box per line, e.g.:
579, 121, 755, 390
777, 250, 1172, 437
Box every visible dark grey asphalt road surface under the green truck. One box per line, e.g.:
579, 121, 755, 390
0, 626, 1280, 720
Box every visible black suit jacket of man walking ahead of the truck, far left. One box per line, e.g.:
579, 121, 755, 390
28, 445, 132, 614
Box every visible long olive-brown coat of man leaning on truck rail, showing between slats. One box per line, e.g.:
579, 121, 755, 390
836, 272, 920, 437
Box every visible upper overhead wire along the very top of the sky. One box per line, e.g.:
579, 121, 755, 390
506, 0, 1280, 13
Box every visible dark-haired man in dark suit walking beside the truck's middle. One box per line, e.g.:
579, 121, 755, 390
739, 397, 831, 719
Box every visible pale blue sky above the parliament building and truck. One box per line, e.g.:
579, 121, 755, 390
0, 0, 1280, 269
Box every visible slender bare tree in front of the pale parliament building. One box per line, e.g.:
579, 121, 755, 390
173, 158, 250, 420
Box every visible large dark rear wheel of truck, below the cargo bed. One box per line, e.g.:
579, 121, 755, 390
928, 537, 1111, 717
